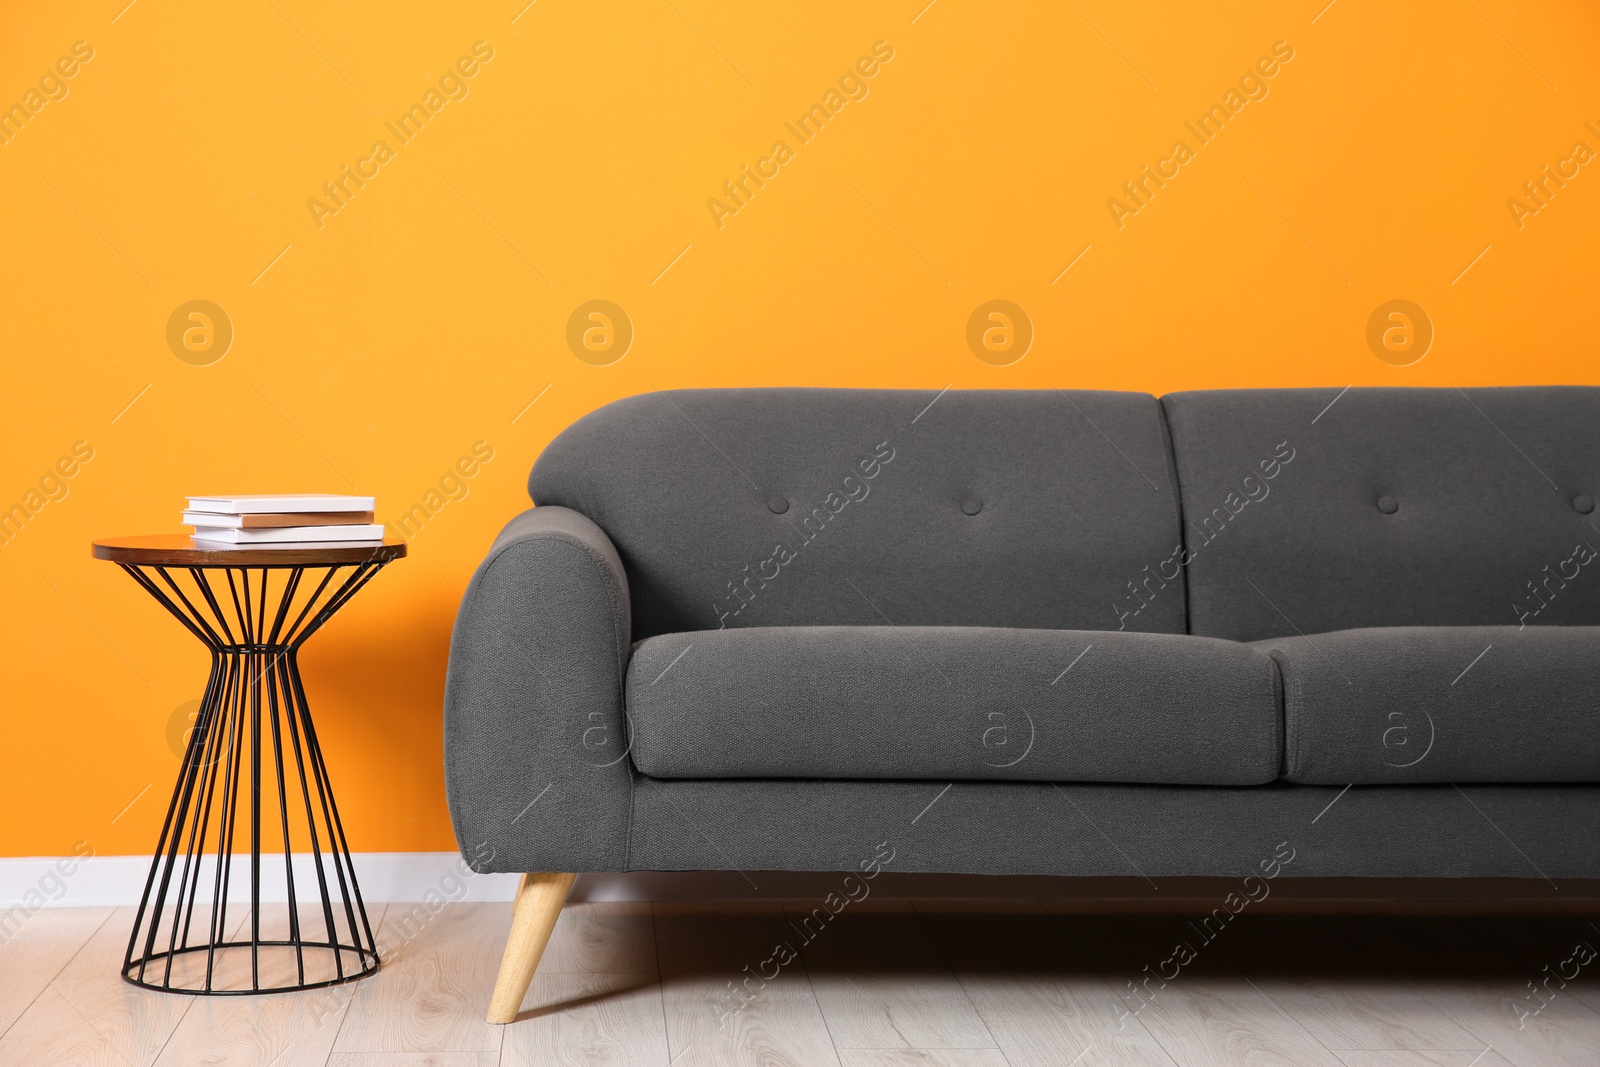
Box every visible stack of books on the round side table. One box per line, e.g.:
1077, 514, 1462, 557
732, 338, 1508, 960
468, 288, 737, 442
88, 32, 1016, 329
184, 493, 384, 549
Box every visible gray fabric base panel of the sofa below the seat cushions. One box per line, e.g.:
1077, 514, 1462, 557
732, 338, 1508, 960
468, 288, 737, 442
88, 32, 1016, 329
629, 777, 1600, 885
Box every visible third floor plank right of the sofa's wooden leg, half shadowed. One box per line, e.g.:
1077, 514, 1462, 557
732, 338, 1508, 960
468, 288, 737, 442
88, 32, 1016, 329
784, 901, 995, 1049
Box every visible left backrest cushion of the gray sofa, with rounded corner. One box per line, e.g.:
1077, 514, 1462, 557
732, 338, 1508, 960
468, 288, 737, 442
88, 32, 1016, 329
528, 389, 1184, 640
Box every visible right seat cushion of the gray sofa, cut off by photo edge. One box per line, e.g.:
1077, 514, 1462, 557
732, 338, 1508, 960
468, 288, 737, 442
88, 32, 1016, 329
1258, 625, 1600, 785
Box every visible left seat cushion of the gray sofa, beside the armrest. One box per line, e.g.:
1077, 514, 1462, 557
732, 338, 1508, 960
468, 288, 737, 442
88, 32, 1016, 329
627, 625, 1282, 785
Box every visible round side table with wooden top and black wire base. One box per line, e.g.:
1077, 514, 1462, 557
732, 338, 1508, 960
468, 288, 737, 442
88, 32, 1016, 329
94, 534, 405, 995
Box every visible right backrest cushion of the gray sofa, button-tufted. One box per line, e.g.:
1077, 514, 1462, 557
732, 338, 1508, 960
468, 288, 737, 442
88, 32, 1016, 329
1162, 386, 1600, 640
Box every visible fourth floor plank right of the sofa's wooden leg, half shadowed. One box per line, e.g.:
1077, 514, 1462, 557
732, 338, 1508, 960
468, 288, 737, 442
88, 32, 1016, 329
917, 901, 1173, 1067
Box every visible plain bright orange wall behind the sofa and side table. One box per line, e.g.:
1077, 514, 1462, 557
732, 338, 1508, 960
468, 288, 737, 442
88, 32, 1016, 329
0, 0, 1600, 856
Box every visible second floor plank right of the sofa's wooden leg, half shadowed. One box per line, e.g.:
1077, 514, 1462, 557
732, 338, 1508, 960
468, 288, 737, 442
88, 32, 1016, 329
653, 902, 838, 1067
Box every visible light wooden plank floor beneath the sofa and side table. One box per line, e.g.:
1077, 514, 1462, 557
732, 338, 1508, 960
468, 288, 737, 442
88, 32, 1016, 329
0, 897, 1600, 1067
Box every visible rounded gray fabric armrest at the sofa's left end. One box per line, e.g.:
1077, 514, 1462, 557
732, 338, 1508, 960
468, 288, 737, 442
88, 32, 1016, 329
445, 507, 634, 872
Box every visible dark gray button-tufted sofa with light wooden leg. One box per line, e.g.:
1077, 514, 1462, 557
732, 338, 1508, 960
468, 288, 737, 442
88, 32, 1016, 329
445, 387, 1600, 1016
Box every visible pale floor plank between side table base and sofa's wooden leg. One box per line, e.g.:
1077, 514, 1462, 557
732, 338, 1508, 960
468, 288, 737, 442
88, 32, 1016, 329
334, 902, 510, 1053
